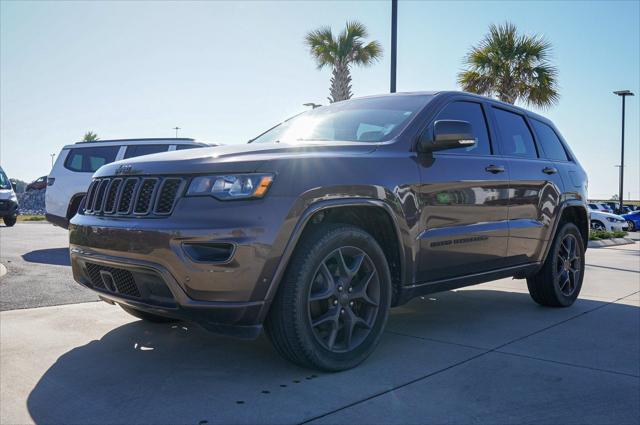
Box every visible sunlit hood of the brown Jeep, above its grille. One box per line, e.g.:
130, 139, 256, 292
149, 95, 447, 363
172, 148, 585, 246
94, 142, 377, 177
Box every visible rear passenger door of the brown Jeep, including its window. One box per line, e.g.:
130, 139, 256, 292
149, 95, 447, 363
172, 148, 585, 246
491, 106, 562, 266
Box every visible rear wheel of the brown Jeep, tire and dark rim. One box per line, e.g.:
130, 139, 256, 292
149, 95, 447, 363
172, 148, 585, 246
527, 223, 584, 307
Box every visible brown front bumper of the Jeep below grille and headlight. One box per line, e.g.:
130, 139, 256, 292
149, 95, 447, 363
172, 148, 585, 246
69, 198, 296, 338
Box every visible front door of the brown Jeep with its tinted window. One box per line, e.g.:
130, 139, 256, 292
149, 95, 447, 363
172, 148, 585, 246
417, 98, 509, 282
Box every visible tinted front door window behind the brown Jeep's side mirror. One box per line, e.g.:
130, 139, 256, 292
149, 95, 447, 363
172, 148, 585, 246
436, 102, 491, 155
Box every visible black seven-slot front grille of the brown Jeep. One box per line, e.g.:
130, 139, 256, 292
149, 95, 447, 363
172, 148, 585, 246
84, 177, 185, 216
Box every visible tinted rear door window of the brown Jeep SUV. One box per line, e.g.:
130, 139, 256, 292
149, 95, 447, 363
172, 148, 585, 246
493, 108, 538, 158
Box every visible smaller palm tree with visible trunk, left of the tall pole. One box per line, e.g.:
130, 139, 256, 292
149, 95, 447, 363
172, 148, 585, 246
305, 21, 382, 103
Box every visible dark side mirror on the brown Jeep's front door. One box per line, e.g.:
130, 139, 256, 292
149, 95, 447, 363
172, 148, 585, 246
418, 120, 476, 152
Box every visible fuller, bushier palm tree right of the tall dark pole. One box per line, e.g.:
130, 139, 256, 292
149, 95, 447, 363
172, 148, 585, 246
458, 22, 559, 108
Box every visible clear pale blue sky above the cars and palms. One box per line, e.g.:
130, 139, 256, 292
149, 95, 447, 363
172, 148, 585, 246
0, 0, 640, 199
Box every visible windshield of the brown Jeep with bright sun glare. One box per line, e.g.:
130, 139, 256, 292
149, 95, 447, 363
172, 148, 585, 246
251, 95, 433, 143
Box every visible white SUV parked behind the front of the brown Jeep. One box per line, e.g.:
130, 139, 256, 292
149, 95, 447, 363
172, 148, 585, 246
45, 138, 215, 229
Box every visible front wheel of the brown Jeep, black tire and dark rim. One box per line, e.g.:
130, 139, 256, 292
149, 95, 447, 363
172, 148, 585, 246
265, 224, 391, 372
